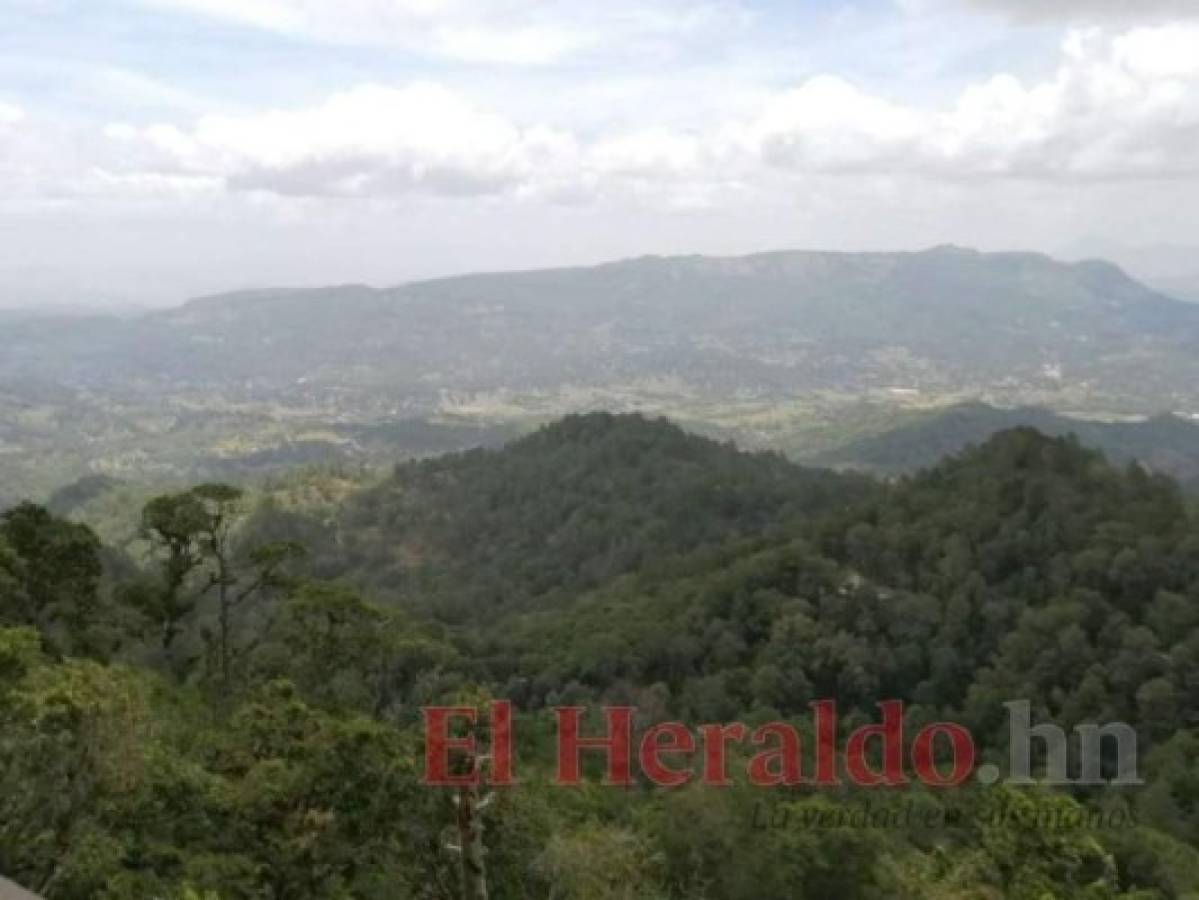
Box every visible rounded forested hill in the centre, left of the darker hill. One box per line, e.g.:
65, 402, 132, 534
267, 413, 873, 618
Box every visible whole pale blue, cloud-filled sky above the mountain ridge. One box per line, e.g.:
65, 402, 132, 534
0, 0, 1199, 307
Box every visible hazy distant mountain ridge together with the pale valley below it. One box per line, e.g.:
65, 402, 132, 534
0, 247, 1199, 496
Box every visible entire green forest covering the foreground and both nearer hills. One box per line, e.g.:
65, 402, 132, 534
0, 413, 1199, 900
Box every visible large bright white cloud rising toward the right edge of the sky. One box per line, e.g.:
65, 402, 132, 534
746, 24, 1199, 180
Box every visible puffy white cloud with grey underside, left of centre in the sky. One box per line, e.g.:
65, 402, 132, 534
108, 83, 585, 197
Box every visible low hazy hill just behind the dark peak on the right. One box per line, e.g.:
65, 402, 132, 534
813, 403, 1199, 483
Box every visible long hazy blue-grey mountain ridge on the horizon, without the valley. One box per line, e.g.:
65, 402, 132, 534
7, 247, 1199, 404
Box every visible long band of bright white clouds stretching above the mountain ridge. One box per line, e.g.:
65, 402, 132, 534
77, 24, 1199, 207
